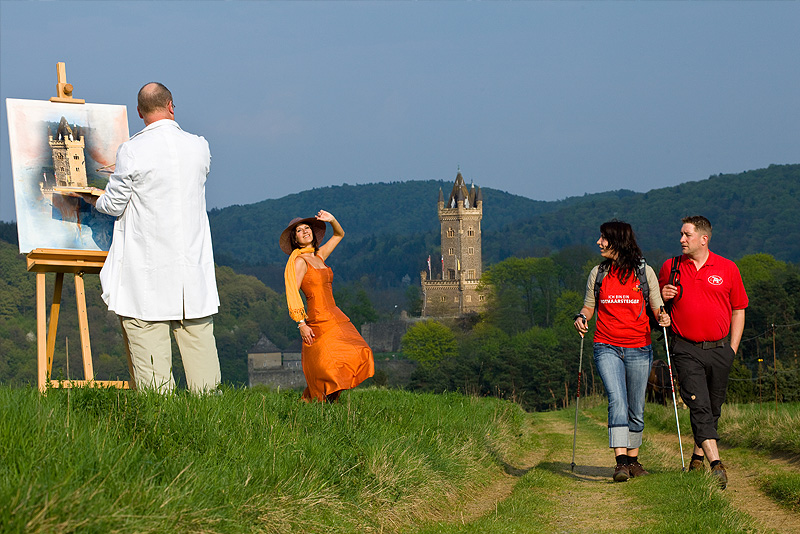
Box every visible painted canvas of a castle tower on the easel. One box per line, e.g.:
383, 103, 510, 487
6, 98, 128, 253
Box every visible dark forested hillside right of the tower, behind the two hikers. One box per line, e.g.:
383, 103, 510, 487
484, 165, 800, 263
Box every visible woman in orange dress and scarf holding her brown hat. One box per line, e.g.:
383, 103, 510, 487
280, 210, 375, 402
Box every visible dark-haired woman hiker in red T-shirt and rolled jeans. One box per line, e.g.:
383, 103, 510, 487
575, 220, 670, 482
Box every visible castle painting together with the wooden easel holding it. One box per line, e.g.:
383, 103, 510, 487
6, 63, 133, 390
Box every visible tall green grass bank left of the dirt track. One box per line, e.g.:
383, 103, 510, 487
0, 387, 524, 533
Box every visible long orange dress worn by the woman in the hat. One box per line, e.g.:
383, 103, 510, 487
300, 256, 375, 401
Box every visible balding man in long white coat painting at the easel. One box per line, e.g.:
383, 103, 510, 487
84, 83, 221, 392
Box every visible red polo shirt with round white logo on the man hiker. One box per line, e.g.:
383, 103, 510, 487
658, 251, 748, 342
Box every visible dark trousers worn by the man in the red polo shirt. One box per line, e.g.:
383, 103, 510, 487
672, 336, 734, 447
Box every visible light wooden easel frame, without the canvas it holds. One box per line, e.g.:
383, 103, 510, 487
27, 62, 134, 391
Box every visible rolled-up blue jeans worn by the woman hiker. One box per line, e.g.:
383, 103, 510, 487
594, 343, 653, 449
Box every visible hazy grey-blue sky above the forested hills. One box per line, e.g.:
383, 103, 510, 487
0, 0, 800, 221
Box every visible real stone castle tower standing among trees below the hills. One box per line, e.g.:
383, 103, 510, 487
421, 171, 484, 317
